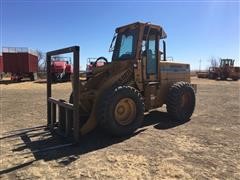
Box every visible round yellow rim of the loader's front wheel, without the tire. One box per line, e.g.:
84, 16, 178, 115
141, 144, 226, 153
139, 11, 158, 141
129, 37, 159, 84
114, 98, 136, 125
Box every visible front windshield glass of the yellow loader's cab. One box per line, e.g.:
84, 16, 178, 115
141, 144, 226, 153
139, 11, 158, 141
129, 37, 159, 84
112, 30, 137, 61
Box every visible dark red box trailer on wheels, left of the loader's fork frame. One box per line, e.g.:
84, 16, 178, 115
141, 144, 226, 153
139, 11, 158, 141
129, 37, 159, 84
2, 47, 38, 81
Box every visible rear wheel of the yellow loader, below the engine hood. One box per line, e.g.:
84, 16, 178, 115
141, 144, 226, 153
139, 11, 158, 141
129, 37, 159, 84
167, 82, 196, 122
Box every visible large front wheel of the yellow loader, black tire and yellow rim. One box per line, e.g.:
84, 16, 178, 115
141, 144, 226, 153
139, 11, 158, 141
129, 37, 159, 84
97, 86, 144, 137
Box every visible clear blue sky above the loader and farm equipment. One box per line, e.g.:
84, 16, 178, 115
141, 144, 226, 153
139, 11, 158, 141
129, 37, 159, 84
1, 0, 240, 69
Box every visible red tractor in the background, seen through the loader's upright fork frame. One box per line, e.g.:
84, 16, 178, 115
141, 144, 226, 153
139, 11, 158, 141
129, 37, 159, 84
51, 56, 73, 82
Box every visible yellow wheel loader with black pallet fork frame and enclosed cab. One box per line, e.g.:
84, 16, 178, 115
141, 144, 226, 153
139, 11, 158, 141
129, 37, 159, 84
47, 22, 196, 141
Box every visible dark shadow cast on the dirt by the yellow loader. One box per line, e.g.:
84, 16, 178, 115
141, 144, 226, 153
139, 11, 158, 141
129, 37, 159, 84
0, 111, 190, 175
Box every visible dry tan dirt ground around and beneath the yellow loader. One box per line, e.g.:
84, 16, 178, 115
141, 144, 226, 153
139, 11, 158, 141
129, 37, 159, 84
0, 77, 240, 180
